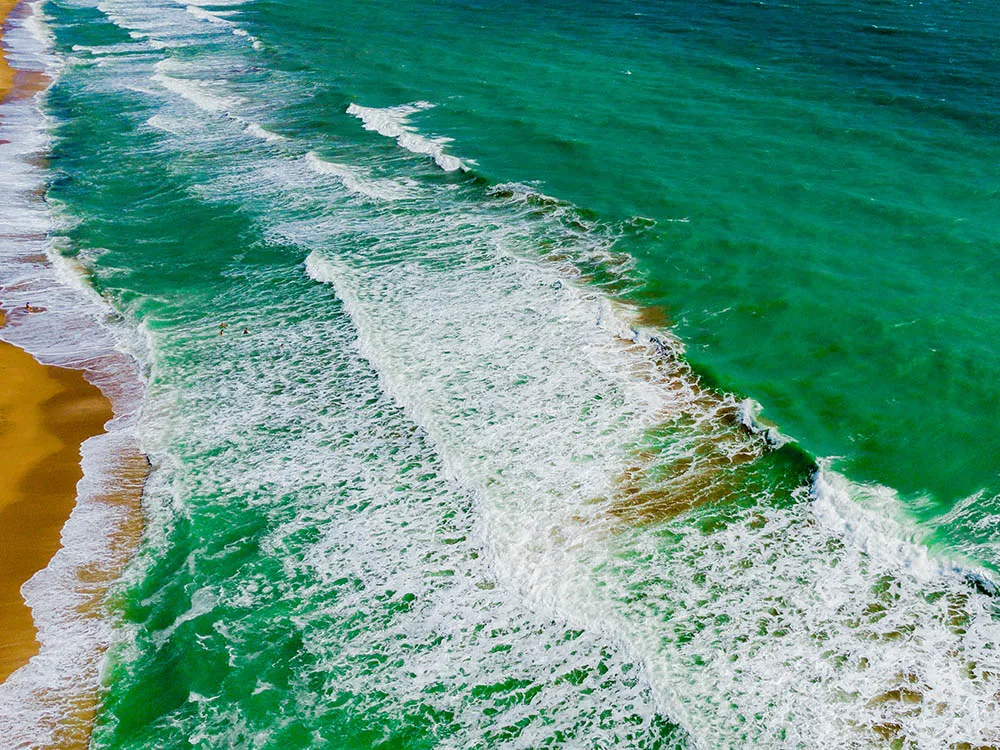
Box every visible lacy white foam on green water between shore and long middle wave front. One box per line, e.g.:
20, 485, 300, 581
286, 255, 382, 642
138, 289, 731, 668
103, 270, 680, 747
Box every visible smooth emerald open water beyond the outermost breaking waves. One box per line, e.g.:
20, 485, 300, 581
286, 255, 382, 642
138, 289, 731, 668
250, 2, 1000, 506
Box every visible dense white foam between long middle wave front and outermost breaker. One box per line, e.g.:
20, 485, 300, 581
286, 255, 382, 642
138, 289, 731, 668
307, 224, 1000, 747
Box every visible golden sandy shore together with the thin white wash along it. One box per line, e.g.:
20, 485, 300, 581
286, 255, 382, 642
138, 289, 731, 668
0, 0, 150, 750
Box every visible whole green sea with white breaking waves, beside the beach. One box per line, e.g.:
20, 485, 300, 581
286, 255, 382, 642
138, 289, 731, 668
11, 0, 1000, 748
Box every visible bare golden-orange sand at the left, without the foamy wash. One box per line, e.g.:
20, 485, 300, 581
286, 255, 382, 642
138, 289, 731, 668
0, 0, 112, 692
